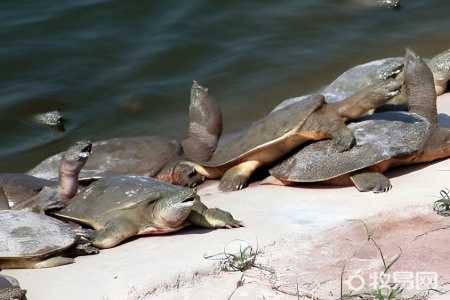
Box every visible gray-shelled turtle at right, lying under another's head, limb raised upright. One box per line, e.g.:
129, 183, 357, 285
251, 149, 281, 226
265, 48, 450, 192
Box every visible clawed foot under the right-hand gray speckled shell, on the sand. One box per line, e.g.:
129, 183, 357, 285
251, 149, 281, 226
350, 172, 392, 193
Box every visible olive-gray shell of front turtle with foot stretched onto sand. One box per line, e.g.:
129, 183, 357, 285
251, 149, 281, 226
54, 175, 194, 229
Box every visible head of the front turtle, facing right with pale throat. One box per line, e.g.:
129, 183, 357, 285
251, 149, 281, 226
152, 188, 199, 231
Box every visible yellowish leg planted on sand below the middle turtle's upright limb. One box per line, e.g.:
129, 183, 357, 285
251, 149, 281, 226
219, 160, 262, 192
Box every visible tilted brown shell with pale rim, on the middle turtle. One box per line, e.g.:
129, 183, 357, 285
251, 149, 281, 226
202, 94, 325, 166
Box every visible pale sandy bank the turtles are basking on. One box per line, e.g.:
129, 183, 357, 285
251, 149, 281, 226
1, 99, 450, 300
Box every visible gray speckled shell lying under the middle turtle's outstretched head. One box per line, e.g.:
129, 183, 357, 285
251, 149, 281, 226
270, 112, 432, 182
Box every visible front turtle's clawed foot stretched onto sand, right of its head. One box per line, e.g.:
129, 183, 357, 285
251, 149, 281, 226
187, 201, 245, 228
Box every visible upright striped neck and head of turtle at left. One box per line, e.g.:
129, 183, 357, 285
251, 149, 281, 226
59, 140, 92, 201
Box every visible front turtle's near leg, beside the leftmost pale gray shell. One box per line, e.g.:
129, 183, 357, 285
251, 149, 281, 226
92, 218, 139, 249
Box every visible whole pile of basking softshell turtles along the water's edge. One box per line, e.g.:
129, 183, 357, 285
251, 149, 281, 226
0, 48, 450, 299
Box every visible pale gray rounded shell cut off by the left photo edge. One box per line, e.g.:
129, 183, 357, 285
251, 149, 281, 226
0, 210, 76, 259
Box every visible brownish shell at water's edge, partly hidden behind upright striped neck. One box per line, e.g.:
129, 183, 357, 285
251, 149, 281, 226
27, 136, 182, 180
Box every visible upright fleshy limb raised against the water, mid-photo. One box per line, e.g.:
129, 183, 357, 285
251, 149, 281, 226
181, 80, 222, 162
